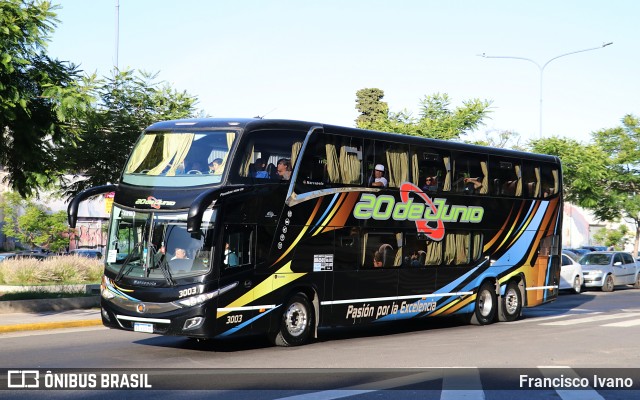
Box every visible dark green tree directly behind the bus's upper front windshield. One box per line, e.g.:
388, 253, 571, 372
58, 70, 196, 195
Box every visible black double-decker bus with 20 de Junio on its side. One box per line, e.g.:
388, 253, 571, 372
68, 119, 562, 346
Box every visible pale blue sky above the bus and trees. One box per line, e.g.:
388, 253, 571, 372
48, 0, 640, 144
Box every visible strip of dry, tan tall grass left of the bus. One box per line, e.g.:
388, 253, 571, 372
0, 256, 104, 301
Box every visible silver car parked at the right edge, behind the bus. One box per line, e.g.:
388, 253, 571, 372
580, 251, 640, 292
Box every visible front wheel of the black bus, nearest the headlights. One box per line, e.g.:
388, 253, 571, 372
271, 293, 314, 347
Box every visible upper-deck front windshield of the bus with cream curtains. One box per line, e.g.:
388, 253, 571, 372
122, 129, 237, 186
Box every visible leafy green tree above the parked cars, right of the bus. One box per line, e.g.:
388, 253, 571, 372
532, 115, 640, 254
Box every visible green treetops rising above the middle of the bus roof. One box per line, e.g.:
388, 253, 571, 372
356, 89, 491, 140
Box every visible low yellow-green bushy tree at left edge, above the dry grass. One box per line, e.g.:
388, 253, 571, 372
0, 192, 69, 251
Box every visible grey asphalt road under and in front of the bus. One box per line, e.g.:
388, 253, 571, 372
0, 288, 640, 399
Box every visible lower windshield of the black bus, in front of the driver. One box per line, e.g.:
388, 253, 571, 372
107, 206, 216, 284
